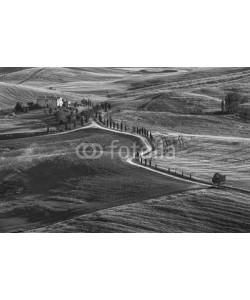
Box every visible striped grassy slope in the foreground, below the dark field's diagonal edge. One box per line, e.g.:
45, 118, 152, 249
32, 189, 250, 232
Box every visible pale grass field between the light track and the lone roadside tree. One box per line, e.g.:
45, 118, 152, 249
155, 137, 250, 190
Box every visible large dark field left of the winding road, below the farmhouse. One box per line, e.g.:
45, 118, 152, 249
0, 129, 198, 231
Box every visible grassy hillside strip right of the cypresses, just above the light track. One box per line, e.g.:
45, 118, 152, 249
112, 110, 250, 138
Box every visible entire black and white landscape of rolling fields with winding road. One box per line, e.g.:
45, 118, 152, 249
0, 67, 250, 232
